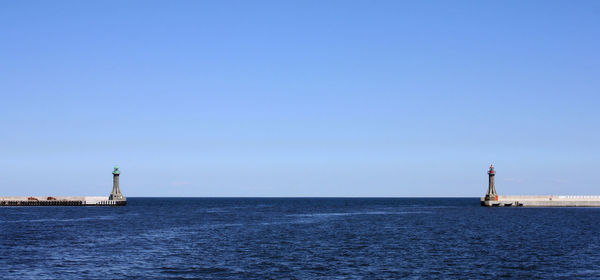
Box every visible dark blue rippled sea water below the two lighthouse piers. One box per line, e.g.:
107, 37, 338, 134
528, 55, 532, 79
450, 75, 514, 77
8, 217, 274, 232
0, 198, 600, 279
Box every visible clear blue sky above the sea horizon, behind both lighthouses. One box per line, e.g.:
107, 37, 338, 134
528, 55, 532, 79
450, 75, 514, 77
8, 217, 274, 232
0, 0, 600, 196
